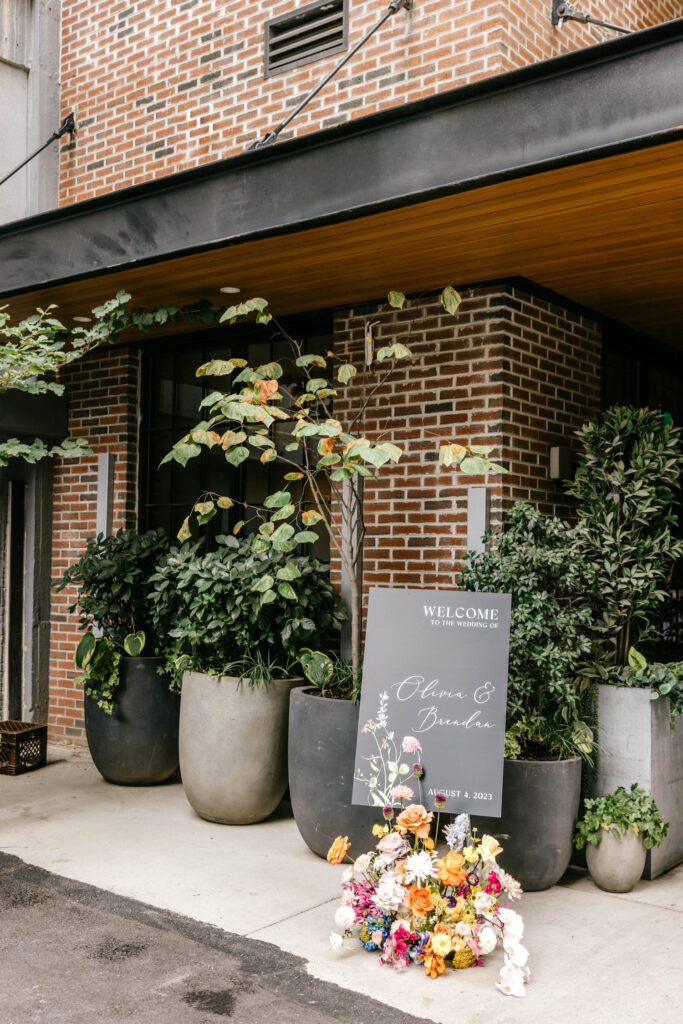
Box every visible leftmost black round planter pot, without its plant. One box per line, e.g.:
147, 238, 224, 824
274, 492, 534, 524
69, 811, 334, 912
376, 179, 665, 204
84, 657, 180, 785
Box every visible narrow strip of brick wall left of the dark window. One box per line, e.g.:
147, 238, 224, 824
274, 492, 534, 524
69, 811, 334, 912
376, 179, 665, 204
48, 348, 139, 742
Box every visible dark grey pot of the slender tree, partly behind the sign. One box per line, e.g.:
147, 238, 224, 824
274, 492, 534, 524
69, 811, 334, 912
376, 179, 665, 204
289, 686, 381, 857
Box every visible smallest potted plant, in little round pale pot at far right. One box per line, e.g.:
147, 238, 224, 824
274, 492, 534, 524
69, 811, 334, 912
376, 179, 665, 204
574, 782, 669, 893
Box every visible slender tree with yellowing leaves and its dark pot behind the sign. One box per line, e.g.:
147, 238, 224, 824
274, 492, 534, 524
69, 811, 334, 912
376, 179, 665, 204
160, 287, 502, 856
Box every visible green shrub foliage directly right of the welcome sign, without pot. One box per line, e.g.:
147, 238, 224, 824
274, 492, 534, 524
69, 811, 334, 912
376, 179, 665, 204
458, 502, 594, 759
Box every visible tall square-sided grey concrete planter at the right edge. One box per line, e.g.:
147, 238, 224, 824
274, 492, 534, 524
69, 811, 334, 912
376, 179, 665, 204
593, 683, 683, 879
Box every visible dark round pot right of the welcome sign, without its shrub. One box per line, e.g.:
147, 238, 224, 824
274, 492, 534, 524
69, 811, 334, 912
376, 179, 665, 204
472, 758, 581, 892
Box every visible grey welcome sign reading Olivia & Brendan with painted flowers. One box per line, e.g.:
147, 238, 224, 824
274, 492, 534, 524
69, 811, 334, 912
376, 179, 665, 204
352, 588, 510, 817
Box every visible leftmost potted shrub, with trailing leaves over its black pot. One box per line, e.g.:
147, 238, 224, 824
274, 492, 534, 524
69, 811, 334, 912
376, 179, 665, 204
54, 529, 179, 785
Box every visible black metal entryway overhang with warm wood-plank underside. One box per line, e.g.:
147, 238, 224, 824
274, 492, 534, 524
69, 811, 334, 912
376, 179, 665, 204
0, 19, 683, 343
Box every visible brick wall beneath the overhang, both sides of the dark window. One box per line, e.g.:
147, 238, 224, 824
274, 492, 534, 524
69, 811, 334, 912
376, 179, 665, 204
44, 285, 601, 742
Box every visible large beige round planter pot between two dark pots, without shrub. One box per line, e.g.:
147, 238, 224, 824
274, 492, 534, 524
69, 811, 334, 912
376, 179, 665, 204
180, 672, 302, 825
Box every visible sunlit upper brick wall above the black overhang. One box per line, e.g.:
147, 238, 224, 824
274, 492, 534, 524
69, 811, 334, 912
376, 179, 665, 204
59, 0, 683, 205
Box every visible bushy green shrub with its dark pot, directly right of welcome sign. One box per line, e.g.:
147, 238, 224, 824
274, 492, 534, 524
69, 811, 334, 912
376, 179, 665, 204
458, 502, 593, 890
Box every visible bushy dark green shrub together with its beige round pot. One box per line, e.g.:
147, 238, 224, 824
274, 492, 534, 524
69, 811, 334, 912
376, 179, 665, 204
151, 536, 342, 824
